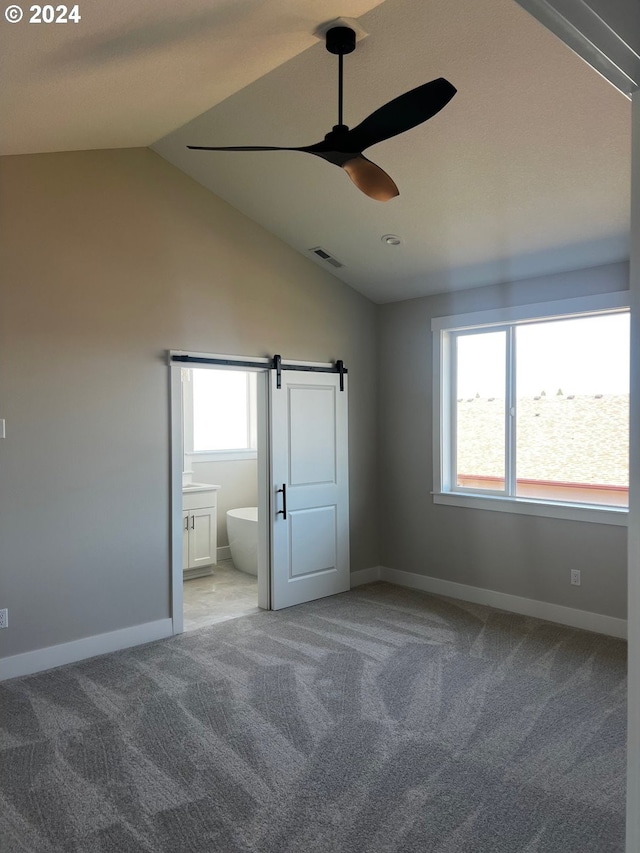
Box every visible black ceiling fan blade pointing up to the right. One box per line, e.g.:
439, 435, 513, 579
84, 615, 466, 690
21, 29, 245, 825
349, 77, 457, 151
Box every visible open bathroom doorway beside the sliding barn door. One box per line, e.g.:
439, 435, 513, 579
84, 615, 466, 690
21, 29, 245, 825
172, 356, 268, 631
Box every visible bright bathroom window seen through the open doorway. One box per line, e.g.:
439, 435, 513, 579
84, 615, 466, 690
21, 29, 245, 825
182, 368, 257, 462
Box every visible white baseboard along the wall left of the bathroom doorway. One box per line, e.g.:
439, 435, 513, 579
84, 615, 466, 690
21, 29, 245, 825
0, 619, 173, 681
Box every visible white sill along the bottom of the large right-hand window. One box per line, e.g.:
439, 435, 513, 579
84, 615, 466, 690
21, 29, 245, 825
432, 492, 629, 527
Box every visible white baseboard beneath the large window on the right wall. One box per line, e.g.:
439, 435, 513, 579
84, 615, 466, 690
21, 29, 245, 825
379, 566, 627, 639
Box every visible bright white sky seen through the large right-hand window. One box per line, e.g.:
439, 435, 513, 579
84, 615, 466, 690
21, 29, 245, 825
457, 312, 629, 398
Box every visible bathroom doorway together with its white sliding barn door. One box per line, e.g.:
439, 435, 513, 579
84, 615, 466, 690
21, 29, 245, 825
169, 352, 350, 633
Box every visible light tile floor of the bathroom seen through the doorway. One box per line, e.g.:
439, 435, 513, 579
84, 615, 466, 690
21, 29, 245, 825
182, 560, 259, 631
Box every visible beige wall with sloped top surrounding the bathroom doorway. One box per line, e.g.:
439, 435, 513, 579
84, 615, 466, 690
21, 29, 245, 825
0, 149, 378, 656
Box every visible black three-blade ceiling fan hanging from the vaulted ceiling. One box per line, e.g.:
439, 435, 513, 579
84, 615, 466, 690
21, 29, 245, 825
187, 26, 456, 201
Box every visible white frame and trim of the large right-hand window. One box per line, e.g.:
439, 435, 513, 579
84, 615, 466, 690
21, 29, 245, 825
431, 291, 629, 526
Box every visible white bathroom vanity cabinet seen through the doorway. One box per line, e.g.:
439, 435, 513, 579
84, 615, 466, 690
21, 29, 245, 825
182, 483, 220, 580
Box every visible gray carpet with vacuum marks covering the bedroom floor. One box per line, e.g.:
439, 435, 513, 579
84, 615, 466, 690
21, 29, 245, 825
0, 584, 626, 853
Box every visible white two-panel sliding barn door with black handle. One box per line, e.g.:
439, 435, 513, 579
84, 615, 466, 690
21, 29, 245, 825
270, 369, 350, 610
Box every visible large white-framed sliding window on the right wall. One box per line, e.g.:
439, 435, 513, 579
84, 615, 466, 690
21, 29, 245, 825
432, 294, 629, 523
